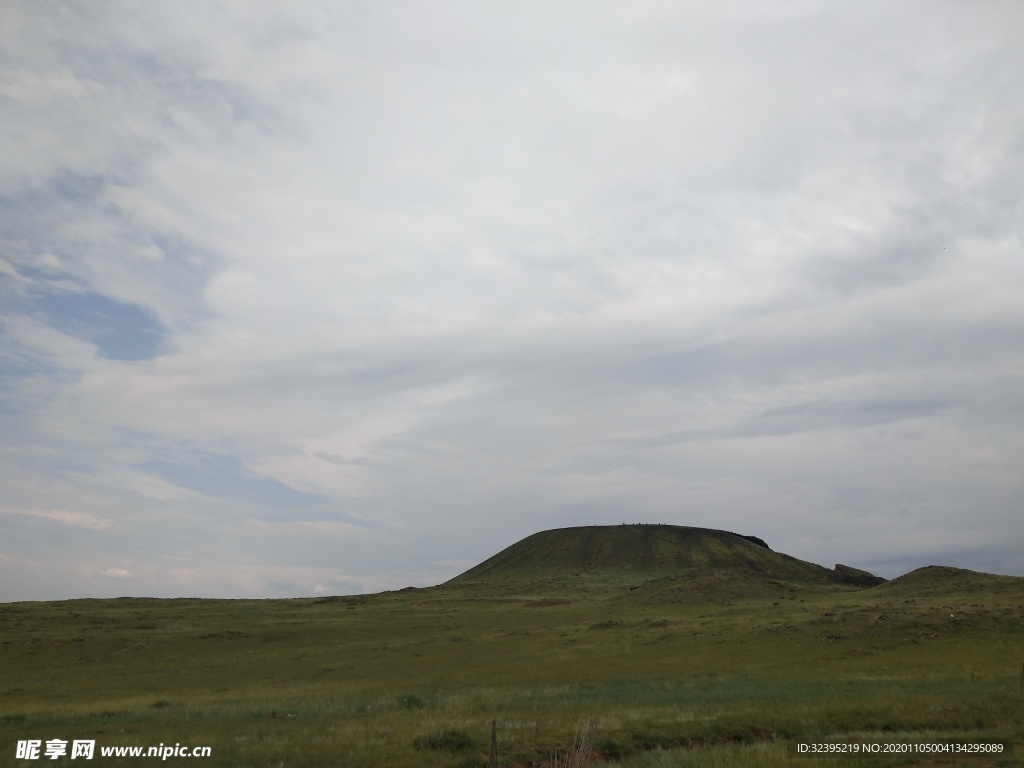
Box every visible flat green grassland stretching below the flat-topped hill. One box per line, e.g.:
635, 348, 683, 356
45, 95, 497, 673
0, 570, 1024, 768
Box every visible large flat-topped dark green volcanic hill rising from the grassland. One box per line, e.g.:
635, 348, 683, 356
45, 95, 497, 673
447, 524, 885, 602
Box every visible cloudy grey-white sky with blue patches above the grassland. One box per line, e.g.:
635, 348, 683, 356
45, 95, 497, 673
0, 0, 1024, 601
